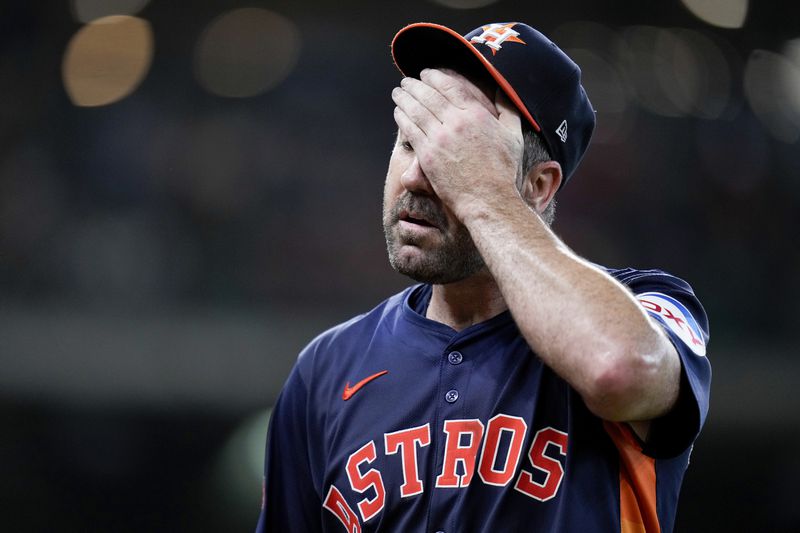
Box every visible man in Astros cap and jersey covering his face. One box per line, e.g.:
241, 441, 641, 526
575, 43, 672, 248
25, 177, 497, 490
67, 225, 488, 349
258, 23, 711, 533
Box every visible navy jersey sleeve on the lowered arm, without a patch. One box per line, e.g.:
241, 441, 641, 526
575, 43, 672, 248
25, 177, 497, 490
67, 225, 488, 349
256, 365, 321, 533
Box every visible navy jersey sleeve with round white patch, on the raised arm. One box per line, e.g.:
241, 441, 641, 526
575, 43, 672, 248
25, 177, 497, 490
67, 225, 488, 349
615, 270, 711, 458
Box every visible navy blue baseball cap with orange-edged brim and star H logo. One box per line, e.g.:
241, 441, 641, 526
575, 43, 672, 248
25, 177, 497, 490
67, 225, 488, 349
392, 22, 595, 186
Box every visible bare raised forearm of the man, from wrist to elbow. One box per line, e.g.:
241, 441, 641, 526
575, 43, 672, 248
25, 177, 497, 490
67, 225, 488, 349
464, 193, 680, 421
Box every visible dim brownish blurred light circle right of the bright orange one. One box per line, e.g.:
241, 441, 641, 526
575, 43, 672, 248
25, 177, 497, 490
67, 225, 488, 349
195, 8, 300, 98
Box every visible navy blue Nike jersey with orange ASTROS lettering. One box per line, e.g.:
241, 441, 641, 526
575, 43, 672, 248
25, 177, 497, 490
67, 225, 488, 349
258, 269, 711, 533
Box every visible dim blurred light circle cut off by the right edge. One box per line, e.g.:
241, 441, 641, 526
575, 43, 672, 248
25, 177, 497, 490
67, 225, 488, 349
744, 50, 800, 143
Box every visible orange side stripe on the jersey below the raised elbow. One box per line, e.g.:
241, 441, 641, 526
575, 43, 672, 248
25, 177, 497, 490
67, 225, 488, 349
603, 422, 661, 533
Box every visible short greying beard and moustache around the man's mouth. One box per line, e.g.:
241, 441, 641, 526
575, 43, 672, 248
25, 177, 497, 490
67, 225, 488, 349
383, 193, 486, 285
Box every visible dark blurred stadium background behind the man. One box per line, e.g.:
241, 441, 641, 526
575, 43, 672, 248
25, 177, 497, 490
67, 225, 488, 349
0, 0, 800, 532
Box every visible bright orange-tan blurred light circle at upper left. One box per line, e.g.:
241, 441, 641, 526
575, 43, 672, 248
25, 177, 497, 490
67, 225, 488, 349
62, 15, 153, 107
